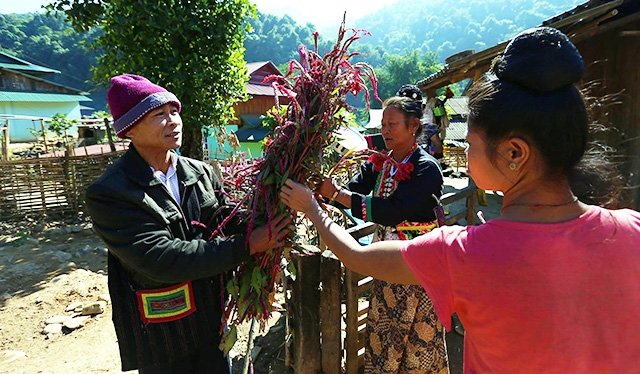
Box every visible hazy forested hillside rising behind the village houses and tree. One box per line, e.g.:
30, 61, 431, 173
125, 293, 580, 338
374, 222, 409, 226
0, 0, 585, 109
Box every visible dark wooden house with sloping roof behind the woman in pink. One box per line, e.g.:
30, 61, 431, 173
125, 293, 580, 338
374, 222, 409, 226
418, 0, 640, 209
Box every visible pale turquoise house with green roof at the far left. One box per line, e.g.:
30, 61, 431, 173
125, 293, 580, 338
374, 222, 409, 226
0, 52, 91, 142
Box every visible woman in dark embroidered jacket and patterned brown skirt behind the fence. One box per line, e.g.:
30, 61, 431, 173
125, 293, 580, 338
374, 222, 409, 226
318, 86, 448, 373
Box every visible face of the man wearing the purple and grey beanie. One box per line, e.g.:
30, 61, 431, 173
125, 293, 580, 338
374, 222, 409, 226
127, 103, 182, 151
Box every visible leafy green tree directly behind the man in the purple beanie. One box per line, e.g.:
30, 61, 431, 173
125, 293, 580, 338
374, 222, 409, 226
49, 0, 255, 159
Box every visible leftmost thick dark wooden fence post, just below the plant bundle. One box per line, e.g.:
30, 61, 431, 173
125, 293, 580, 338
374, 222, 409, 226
287, 245, 322, 374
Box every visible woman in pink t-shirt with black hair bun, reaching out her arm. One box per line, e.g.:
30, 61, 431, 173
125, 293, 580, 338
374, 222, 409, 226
281, 28, 640, 373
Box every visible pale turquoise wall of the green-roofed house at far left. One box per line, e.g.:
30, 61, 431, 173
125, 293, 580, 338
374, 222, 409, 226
0, 101, 80, 143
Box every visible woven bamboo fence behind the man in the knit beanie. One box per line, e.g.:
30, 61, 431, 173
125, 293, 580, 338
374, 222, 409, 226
0, 151, 123, 221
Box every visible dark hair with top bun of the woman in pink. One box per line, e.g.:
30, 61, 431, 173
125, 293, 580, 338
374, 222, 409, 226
468, 27, 620, 206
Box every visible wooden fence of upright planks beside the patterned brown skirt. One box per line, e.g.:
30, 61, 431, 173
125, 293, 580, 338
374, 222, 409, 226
285, 185, 477, 374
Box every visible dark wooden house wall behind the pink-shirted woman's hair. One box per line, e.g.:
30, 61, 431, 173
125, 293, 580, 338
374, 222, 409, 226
576, 21, 640, 209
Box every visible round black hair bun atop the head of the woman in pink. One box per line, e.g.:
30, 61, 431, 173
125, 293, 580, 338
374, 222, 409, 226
493, 27, 584, 92
